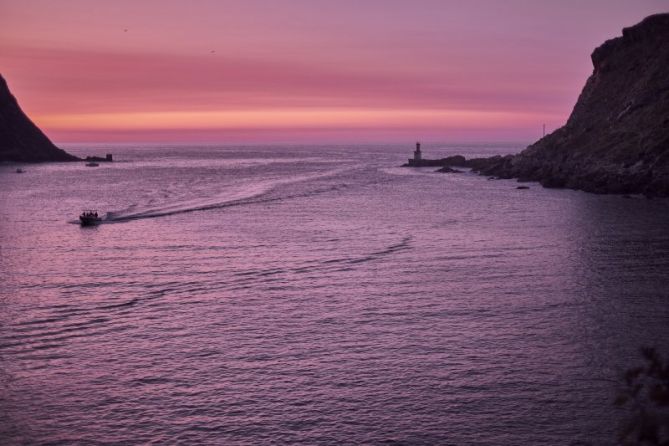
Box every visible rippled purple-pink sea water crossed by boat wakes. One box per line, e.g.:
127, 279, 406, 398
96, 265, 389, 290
0, 146, 669, 445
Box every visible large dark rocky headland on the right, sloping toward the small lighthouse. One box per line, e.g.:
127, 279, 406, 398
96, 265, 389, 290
412, 14, 669, 197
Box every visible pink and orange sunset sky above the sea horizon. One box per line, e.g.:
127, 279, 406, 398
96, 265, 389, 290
0, 0, 669, 143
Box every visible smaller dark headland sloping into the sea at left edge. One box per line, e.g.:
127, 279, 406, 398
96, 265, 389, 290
0, 75, 79, 163
